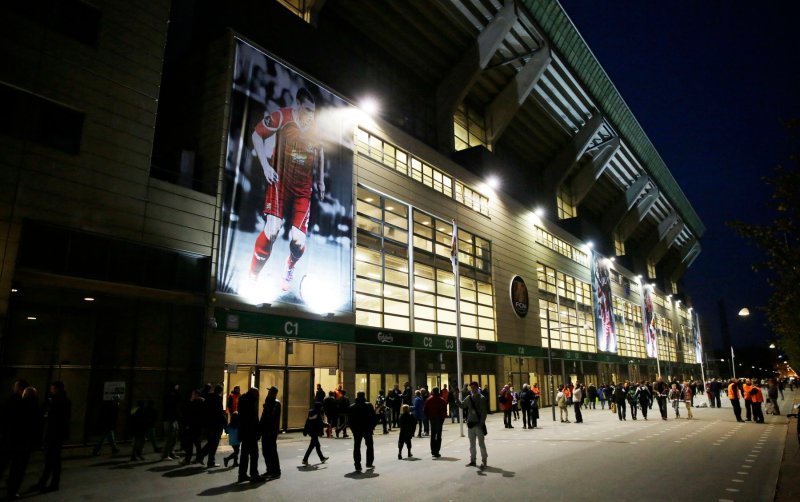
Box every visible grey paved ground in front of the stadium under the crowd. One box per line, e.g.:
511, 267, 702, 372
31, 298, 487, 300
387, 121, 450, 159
0, 392, 800, 501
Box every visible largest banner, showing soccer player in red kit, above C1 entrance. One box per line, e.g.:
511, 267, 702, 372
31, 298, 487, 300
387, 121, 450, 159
217, 39, 355, 313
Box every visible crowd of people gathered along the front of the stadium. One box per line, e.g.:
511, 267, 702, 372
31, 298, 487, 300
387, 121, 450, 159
0, 377, 794, 499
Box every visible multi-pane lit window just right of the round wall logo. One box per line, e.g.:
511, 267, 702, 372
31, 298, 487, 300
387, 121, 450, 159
536, 263, 597, 352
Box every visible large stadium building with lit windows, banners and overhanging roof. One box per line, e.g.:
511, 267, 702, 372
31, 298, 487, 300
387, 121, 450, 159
0, 0, 704, 442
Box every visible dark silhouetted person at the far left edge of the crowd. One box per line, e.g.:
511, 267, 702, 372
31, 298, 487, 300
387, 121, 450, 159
6, 381, 42, 500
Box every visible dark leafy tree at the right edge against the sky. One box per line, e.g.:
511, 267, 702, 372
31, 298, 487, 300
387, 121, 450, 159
729, 120, 800, 365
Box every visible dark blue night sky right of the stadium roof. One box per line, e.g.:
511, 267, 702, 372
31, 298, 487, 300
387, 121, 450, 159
561, 0, 800, 347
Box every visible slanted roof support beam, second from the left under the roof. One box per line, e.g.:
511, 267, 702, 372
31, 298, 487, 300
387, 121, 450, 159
486, 41, 553, 145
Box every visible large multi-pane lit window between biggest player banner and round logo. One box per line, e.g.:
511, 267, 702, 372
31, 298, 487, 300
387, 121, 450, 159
356, 187, 496, 341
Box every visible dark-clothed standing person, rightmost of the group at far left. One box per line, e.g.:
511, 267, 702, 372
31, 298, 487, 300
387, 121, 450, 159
37, 381, 72, 491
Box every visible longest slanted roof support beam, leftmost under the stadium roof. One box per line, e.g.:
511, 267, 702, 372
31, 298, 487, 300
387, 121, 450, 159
436, 1, 517, 151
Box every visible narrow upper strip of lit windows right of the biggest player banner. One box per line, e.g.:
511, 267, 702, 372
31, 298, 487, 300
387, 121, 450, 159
356, 129, 489, 216
